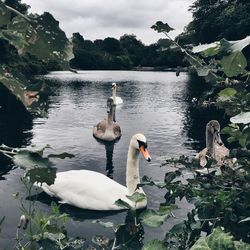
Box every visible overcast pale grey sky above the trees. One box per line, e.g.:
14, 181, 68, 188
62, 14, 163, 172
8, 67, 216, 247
22, 0, 194, 45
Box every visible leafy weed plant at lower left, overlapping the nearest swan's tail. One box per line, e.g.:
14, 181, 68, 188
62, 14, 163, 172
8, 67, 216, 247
15, 162, 85, 249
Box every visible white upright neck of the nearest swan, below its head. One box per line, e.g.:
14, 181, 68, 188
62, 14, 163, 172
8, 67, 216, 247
126, 145, 141, 195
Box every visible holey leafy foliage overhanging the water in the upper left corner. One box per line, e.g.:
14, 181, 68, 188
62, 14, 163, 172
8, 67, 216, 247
0, 0, 72, 115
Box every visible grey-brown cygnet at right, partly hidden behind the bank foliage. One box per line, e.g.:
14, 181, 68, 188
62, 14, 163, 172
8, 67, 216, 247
196, 120, 229, 167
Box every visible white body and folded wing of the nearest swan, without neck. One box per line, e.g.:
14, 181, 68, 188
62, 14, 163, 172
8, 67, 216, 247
39, 170, 127, 210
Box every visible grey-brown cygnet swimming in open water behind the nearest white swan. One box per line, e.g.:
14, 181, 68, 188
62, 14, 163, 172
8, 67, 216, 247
93, 98, 122, 141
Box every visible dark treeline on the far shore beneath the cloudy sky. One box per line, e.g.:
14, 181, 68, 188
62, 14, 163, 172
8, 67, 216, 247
71, 33, 186, 69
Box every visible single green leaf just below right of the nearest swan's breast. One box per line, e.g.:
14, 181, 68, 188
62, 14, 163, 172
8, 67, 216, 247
140, 209, 169, 227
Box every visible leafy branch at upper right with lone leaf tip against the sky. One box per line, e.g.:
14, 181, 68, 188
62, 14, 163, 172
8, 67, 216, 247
151, 21, 250, 116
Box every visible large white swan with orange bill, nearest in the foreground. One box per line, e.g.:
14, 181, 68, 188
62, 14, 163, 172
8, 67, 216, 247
37, 134, 151, 210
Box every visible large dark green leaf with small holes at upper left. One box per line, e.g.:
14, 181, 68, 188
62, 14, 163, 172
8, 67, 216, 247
2, 12, 73, 65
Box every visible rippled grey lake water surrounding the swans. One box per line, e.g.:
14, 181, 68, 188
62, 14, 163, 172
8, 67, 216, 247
0, 71, 227, 249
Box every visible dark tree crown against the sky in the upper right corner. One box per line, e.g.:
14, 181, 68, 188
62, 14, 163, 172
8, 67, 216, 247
177, 0, 250, 45
